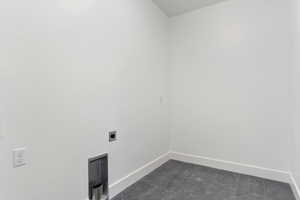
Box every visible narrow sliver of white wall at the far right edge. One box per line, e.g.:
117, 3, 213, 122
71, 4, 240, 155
291, 0, 300, 192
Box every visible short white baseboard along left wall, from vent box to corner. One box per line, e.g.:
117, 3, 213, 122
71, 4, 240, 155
109, 153, 170, 198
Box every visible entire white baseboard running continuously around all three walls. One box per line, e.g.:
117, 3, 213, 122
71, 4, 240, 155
84, 152, 300, 200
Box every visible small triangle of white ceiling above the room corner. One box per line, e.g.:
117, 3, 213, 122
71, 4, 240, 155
152, 0, 224, 17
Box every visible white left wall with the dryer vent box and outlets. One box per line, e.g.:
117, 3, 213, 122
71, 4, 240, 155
0, 0, 169, 200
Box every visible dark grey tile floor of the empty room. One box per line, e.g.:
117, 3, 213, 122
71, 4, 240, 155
113, 160, 295, 200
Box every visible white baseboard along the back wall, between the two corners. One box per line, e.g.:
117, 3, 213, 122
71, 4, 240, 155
170, 152, 291, 183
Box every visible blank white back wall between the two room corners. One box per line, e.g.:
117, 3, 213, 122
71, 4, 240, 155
170, 0, 291, 171
